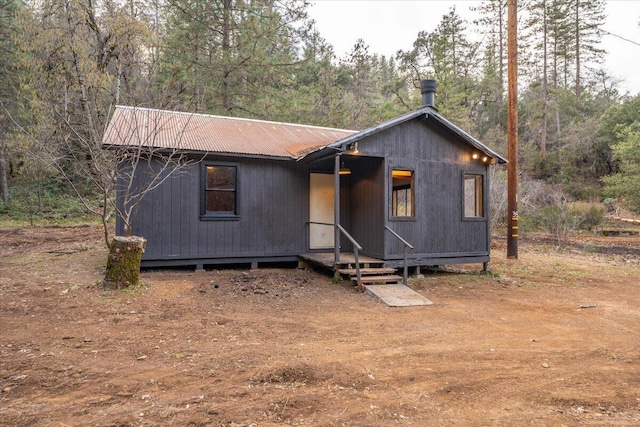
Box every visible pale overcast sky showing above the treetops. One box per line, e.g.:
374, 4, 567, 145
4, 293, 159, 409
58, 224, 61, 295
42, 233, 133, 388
309, 0, 640, 95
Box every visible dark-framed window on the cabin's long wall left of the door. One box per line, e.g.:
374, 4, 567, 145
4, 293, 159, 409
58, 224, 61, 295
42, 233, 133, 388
203, 164, 238, 217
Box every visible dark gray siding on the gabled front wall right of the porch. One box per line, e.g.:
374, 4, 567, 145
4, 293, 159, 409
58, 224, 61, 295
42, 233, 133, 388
352, 118, 489, 265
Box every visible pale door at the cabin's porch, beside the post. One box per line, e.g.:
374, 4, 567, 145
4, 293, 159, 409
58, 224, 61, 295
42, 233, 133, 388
309, 173, 335, 249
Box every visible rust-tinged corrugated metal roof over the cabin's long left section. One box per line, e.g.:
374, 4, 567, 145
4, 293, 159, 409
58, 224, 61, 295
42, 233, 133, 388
103, 106, 356, 159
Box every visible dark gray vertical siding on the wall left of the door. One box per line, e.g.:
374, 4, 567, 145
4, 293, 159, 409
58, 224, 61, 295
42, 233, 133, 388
120, 157, 309, 265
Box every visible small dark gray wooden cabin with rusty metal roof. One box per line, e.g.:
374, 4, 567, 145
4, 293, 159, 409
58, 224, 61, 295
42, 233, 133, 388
104, 80, 506, 283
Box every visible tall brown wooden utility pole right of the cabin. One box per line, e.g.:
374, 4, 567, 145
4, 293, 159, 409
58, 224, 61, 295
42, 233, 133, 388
507, 0, 518, 259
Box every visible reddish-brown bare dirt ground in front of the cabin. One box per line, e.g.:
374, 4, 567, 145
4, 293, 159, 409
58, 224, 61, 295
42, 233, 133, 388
0, 226, 640, 427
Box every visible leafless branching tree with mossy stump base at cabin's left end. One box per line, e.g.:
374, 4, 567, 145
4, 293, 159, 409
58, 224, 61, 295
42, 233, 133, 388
6, 103, 200, 287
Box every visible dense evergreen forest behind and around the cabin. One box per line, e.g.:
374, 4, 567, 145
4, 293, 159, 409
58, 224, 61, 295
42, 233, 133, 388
0, 0, 640, 237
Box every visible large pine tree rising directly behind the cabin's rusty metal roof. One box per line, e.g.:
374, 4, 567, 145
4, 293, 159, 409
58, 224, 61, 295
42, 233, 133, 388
159, 0, 309, 118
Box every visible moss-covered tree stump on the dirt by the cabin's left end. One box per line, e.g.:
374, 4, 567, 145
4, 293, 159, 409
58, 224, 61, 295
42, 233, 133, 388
104, 236, 147, 289
